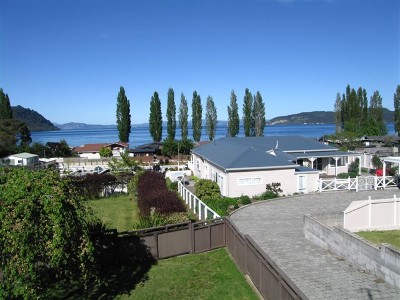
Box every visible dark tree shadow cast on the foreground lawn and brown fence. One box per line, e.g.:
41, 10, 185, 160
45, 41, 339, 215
51, 233, 156, 299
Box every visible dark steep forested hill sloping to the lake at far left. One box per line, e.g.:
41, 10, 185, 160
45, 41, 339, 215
11, 105, 59, 131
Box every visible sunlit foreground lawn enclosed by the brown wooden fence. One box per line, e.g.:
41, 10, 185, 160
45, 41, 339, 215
116, 248, 259, 300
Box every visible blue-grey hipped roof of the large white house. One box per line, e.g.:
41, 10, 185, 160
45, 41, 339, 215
192, 136, 344, 170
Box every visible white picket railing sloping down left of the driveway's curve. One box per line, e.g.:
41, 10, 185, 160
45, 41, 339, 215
178, 181, 221, 220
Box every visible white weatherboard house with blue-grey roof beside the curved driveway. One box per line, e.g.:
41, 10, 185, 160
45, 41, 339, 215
189, 136, 361, 197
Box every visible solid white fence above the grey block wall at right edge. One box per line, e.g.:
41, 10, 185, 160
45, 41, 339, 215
343, 195, 400, 232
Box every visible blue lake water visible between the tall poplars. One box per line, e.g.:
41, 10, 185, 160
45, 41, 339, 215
31, 123, 394, 148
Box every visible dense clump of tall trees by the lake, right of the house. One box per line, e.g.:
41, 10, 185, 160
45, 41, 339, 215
335, 85, 387, 136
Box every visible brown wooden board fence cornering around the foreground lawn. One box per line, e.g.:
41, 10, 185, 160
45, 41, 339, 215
100, 218, 307, 299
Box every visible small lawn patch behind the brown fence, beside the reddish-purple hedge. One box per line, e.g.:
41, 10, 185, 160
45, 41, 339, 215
88, 195, 138, 231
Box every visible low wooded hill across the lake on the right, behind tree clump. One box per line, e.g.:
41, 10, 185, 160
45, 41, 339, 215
267, 108, 394, 125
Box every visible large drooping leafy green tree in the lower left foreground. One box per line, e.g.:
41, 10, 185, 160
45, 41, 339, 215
0, 168, 95, 299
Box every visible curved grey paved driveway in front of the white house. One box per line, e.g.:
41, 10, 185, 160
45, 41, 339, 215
231, 189, 400, 300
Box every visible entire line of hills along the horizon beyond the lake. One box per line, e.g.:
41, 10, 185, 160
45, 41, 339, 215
12, 105, 394, 131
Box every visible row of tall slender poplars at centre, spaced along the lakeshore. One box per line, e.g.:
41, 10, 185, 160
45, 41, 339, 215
117, 87, 266, 142
